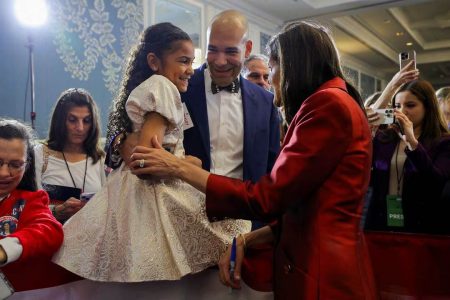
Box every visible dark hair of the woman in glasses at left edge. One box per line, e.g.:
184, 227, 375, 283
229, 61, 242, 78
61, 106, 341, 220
0, 118, 37, 191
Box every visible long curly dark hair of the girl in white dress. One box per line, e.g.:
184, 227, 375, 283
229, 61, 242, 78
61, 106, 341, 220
107, 23, 191, 144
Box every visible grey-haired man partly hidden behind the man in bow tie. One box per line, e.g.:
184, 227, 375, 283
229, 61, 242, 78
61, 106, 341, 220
241, 54, 270, 91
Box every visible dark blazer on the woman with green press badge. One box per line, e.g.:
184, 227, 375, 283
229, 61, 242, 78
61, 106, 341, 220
366, 131, 450, 234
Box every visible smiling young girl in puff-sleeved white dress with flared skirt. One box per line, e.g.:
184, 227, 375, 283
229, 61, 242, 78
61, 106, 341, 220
54, 23, 250, 282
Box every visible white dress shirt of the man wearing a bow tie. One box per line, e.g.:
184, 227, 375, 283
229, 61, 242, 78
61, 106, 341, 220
204, 69, 244, 179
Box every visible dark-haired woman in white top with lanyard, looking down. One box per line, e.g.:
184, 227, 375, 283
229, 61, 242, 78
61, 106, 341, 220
34, 88, 106, 223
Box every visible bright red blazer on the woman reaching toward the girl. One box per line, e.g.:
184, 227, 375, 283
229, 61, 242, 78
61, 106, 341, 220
206, 78, 376, 300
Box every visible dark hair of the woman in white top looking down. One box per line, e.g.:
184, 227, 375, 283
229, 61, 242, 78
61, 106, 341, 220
46, 88, 104, 163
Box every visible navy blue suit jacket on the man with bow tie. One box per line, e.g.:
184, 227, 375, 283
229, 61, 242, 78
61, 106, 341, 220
181, 65, 280, 181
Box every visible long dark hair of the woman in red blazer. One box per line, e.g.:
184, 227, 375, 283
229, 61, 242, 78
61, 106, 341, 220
267, 21, 364, 123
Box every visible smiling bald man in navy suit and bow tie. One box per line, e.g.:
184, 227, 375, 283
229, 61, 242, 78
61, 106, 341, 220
181, 10, 280, 186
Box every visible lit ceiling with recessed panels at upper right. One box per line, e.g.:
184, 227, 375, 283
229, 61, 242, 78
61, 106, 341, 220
231, 0, 450, 88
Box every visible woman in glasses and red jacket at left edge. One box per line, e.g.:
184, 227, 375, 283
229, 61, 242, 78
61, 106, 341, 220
0, 119, 63, 290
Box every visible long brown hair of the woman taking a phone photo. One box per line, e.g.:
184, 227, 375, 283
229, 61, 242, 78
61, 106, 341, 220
392, 79, 448, 146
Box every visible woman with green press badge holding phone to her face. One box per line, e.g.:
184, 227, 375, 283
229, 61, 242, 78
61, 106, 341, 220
366, 80, 450, 233
